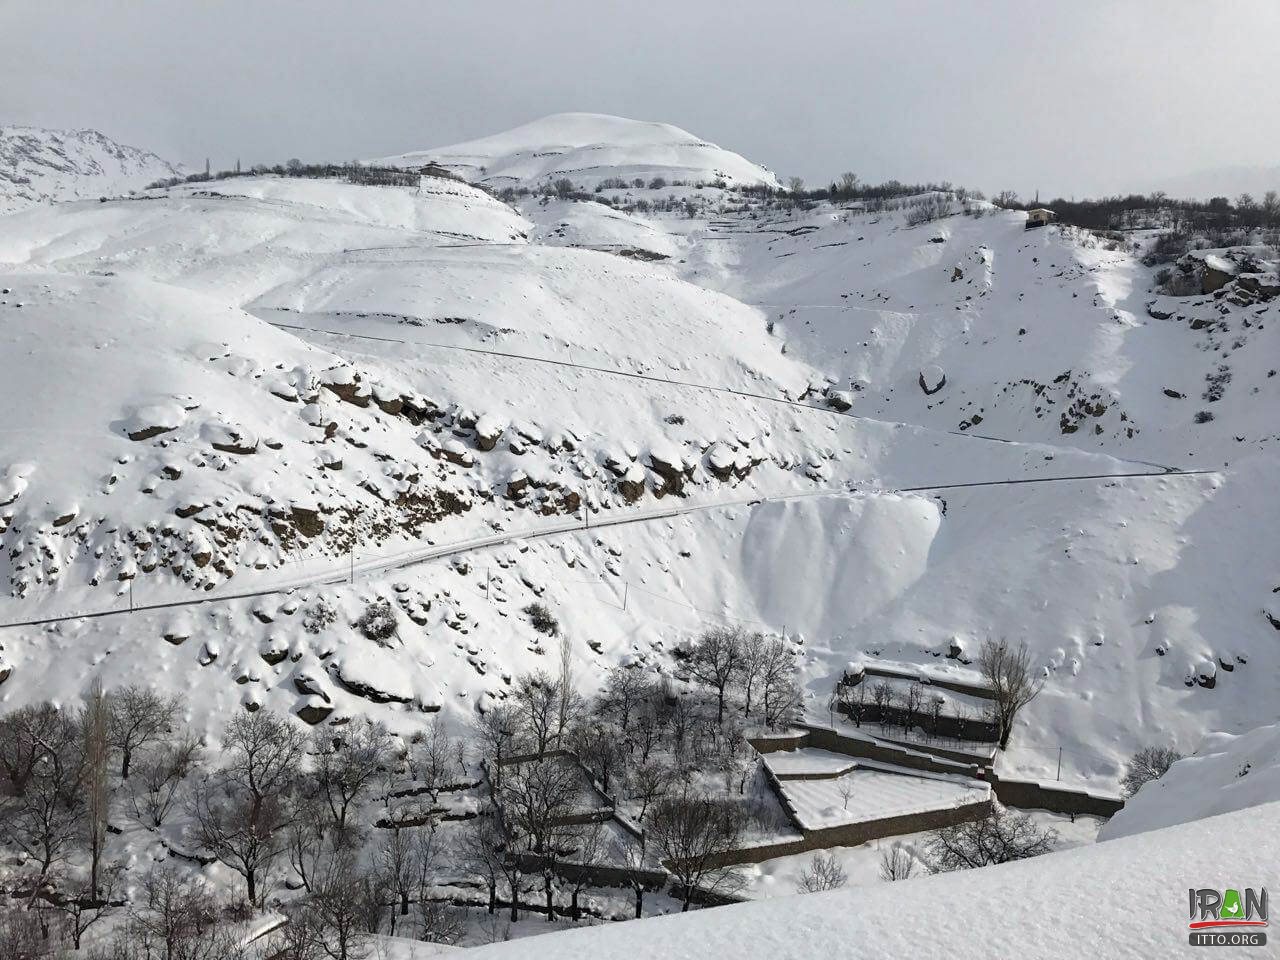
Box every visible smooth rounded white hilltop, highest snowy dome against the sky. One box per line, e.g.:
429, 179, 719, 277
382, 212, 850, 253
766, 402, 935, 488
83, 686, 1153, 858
372, 113, 778, 189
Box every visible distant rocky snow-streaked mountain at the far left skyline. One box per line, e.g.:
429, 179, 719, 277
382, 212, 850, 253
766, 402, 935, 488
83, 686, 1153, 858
0, 125, 178, 214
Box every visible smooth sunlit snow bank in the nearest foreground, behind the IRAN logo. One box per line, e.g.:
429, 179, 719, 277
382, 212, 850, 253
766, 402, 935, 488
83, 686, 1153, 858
475, 803, 1280, 960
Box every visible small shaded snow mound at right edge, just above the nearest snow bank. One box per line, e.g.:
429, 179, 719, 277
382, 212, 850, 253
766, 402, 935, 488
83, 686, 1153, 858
1098, 724, 1280, 840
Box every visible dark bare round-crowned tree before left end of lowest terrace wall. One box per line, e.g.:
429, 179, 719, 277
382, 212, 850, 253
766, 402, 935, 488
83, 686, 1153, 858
648, 794, 744, 913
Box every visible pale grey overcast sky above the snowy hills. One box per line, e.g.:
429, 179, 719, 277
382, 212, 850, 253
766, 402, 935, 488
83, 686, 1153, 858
0, 0, 1280, 196
